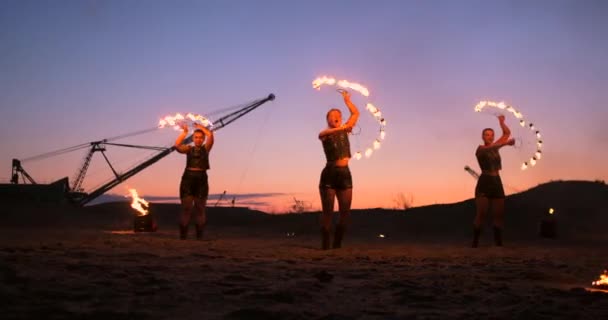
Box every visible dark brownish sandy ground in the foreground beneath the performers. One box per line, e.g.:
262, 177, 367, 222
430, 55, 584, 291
0, 227, 608, 319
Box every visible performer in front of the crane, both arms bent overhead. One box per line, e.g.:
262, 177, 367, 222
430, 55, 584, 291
175, 122, 214, 240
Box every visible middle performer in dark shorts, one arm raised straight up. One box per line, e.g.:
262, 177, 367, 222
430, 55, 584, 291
319, 90, 359, 250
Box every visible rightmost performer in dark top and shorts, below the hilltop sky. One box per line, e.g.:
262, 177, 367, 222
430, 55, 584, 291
472, 115, 515, 248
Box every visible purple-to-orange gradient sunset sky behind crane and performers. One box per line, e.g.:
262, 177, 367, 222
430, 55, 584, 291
0, 0, 608, 212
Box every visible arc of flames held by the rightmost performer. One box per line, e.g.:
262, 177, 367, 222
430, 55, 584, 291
475, 101, 543, 170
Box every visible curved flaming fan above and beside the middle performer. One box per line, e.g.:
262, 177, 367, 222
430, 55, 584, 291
312, 76, 386, 160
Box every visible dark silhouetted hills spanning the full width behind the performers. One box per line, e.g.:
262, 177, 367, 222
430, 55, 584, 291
0, 181, 608, 240
